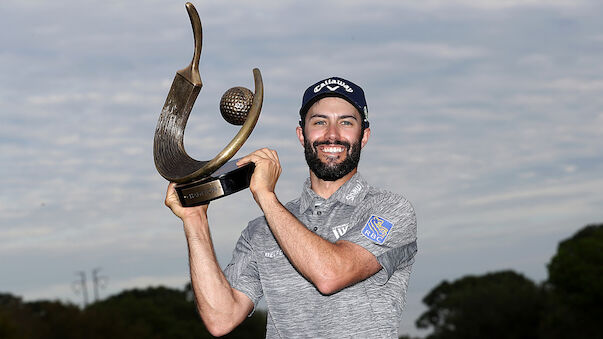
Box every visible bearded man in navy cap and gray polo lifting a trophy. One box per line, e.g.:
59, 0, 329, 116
166, 77, 417, 338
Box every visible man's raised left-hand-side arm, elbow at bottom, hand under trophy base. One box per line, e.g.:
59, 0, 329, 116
165, 183, 253, 336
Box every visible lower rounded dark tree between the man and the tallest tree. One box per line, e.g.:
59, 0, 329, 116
416, 271, 543, 339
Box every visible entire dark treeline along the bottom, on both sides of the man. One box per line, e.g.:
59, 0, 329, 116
0, 224, 603, 339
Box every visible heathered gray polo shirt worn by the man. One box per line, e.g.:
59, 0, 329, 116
224, 173, 417, 338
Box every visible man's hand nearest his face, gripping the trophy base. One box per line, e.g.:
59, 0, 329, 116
237, 148, 282, 203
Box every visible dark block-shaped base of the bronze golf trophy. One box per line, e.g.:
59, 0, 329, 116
175, 160, 255, 207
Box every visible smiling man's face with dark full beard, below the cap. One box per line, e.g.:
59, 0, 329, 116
298, 97, 370, 181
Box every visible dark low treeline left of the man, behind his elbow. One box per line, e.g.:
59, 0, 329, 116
0, 285, 266, 339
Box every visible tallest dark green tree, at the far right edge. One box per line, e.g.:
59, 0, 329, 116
542, 224, 603, 338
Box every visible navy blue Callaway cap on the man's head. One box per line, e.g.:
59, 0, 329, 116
299, 77, 369, 128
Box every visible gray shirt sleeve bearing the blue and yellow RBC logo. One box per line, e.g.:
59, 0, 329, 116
340, 192, 417, 284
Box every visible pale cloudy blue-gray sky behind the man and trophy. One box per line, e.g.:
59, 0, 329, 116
0, 0, 603, 334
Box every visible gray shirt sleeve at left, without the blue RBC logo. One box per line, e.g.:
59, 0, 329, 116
224, 219, 263, 306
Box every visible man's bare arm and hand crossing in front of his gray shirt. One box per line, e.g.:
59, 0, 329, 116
239, 149, 381, 294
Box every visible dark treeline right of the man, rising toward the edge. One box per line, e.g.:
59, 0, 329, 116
416, 224, 603, 339
